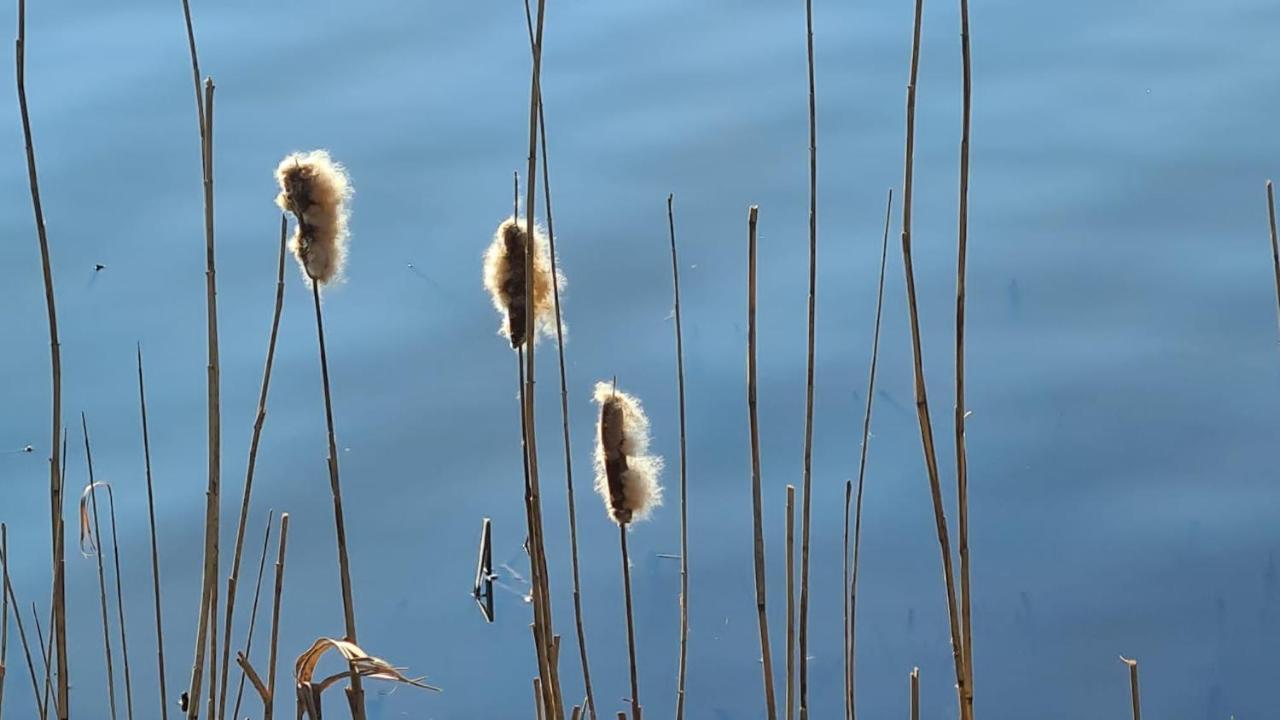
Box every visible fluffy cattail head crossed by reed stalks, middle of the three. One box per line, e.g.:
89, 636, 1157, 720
484, 217, 564, 348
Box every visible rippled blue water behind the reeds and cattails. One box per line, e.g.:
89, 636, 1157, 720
0, 0, 1280, 720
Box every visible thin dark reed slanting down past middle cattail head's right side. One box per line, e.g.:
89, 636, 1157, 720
511, 7, 595, 720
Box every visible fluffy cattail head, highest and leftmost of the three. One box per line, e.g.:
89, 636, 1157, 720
275, 150, 352, 284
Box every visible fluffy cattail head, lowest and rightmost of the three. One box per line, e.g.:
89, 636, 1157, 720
595, 382, 662, 525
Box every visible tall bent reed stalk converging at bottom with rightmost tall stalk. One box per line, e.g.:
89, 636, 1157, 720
902, 0, 969, 720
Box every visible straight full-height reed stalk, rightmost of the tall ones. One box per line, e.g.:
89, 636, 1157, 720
955, 0, 973, 717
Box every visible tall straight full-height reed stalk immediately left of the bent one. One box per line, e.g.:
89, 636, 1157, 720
799, 0, 818, 720
